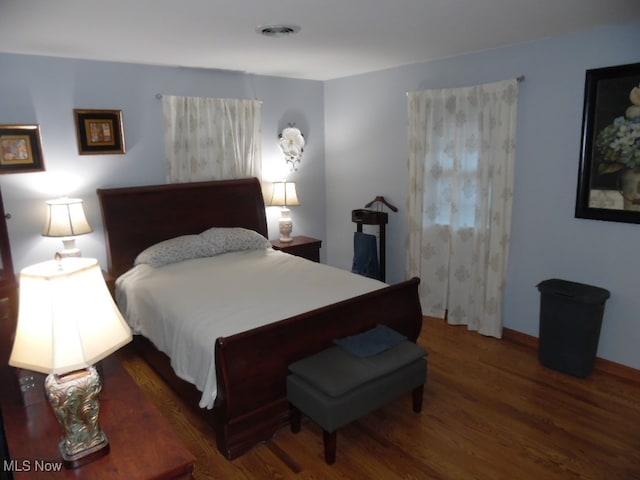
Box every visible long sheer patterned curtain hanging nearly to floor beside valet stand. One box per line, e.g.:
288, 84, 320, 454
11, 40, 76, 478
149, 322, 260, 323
407, 79, 518, 338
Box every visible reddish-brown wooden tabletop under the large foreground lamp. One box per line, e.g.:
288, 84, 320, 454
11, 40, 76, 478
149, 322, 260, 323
0, 354, 195, 480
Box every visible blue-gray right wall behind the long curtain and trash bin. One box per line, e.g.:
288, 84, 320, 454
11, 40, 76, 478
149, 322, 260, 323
325, 23, 640, 368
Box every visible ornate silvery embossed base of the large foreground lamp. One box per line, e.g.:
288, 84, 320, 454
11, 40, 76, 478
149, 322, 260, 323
44, 367, 109, 468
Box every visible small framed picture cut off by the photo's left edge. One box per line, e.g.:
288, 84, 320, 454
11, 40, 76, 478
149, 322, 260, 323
0, 125, 44, 173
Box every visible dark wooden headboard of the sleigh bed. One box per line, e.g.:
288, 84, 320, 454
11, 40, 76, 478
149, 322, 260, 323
97, 178, 268, 277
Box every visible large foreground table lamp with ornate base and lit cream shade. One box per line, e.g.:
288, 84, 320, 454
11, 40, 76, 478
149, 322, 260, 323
9, 255, 132, 468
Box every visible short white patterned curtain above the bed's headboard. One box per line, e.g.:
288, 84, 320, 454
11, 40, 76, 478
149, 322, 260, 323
162, 95, 262, 183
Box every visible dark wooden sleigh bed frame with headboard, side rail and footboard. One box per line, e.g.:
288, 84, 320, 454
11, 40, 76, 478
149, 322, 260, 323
97, 178, 422, 459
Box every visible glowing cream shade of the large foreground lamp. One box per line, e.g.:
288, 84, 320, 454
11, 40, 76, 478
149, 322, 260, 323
9, 258, 132, 374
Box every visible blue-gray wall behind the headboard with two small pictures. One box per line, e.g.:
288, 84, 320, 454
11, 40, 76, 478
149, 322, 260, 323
0, 54, 326, 271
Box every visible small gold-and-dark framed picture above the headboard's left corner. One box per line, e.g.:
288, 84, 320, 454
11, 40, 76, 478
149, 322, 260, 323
73, 109, 125, 155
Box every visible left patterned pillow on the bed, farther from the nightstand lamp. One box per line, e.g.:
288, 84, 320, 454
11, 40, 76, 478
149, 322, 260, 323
133, 235, 215, 268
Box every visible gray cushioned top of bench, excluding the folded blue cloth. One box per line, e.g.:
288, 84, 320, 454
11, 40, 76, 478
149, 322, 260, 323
289, 340, 427, 397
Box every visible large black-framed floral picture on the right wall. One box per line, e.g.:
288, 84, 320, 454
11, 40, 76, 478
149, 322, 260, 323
575, 63, 640, 223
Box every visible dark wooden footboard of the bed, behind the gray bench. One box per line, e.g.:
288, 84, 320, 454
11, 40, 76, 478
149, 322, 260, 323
214, 278, 422, 459
